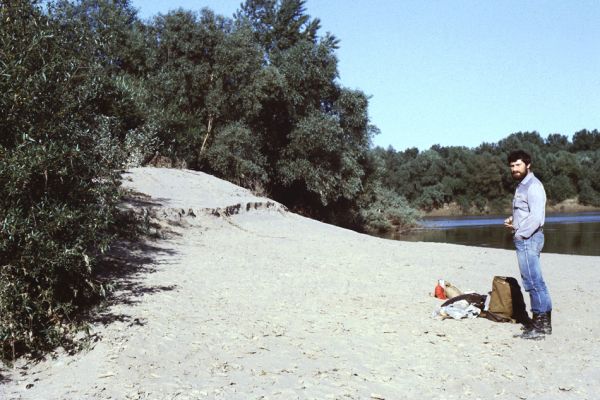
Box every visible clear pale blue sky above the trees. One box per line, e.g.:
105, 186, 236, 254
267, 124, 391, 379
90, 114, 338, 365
132, 0, 600, 150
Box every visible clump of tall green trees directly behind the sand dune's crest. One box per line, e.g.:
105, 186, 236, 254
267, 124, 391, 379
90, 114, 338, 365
147, 0, 382, 227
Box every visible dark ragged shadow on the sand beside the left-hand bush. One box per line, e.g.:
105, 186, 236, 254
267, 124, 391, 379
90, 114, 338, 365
0, 192, 190, 384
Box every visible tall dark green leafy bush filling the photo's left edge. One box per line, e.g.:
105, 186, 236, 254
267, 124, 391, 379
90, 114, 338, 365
0, 1, 122, 359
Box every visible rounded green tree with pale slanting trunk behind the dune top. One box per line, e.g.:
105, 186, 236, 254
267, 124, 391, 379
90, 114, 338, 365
149, 9, 262, 171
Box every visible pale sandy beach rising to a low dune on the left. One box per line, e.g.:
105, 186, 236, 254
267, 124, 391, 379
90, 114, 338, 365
0, 168, 600, 400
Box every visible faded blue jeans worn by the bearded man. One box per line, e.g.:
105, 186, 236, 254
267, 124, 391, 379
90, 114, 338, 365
514, 231, 552, 314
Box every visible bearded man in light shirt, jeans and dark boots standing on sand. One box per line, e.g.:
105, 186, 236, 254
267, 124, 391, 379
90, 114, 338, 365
504, 150, 552, 339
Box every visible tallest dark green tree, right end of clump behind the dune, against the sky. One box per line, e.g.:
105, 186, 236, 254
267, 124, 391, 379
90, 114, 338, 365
236, 0, 374, 214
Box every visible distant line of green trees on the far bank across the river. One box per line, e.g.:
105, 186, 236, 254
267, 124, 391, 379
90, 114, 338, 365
373, 130, 600, 214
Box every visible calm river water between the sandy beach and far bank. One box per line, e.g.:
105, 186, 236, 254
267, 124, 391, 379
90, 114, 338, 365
393, 212, 600, 256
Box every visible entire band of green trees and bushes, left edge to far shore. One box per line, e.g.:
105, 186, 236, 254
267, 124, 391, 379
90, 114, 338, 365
0, 0, 600, 359
